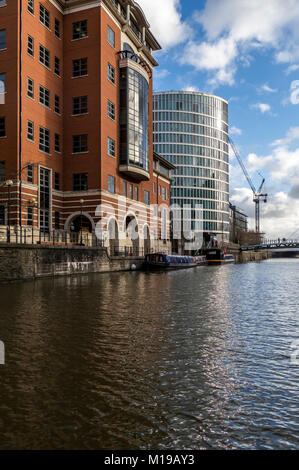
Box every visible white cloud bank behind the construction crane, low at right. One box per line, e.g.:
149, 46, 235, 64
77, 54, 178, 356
230, 127, 299, 238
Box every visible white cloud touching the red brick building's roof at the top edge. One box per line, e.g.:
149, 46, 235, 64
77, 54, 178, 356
137, 0, 190, 49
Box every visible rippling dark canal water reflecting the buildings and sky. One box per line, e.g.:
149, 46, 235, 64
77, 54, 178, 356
0, 259, 299, 450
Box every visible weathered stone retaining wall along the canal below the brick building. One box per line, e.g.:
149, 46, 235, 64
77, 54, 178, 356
0, 245, 144, 282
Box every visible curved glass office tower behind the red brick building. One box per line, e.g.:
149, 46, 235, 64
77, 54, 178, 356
153, 91, 229, 242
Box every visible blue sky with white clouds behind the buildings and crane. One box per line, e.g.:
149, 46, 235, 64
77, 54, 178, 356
138, 0, 299, 238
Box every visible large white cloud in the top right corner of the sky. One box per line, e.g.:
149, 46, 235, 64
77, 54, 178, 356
182, 0, 299, 86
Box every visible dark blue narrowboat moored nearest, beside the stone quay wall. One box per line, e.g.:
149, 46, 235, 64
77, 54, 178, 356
145, 253, 206, 269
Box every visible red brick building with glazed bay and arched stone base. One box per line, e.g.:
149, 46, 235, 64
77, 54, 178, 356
0, 0, 173, 253
